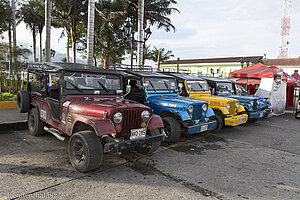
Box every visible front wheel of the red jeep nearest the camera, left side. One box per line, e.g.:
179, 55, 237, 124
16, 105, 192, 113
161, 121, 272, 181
68, 130, 103, 172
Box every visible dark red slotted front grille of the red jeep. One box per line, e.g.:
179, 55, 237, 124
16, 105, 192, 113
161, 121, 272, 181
121, 109, 142, 137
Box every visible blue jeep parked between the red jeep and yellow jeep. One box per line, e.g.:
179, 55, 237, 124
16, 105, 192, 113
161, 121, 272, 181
123, 71, 216, 142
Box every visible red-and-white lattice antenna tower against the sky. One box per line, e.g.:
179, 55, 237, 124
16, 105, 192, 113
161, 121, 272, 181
278, 0, 292, 58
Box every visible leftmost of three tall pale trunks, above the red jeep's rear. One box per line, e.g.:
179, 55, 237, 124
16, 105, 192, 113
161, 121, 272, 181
45, 0, 51, 62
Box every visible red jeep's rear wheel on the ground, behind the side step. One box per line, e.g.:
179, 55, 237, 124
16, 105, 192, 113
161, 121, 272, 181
27, 108, 45, 136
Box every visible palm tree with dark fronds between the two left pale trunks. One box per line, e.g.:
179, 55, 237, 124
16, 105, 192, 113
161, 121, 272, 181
52, 0, 87, 63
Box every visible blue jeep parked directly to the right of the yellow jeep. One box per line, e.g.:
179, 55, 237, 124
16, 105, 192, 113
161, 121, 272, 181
201, 77, 266, 122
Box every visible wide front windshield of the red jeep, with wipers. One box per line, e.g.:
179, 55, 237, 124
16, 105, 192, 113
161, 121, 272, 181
64, 72, 121, 94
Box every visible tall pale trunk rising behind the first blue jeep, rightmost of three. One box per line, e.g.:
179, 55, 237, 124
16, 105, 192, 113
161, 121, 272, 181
137, 0, 145, 68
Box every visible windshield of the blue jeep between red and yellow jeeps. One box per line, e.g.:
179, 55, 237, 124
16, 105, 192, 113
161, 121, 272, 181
145, 78, 177, 91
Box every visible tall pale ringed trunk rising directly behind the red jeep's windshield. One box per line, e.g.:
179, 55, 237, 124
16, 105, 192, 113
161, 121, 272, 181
87, 0, 95, 65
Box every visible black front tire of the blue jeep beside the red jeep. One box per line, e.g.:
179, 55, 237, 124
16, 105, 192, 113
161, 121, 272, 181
162, 117, 181, 142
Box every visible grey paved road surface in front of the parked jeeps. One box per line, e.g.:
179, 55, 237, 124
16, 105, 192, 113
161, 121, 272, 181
0, 114, 300, 200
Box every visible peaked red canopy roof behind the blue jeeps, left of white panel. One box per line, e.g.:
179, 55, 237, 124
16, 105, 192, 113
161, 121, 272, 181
229, 63, 277, 78
